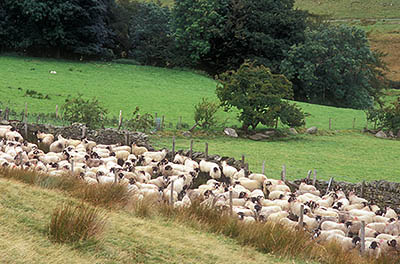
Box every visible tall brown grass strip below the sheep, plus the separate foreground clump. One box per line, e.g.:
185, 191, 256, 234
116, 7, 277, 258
0, 169, 400, 264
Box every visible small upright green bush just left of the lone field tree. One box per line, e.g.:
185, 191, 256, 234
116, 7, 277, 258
194, 98, 219, 129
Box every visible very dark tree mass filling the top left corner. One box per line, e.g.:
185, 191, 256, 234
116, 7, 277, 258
3, 0, 113, 57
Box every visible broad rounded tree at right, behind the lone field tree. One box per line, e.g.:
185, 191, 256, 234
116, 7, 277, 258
281, 25, 385, 109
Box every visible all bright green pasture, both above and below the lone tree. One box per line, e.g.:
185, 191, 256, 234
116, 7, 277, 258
0, 56, 400, 181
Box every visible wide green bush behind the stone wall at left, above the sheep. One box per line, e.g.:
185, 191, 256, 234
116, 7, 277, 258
61, 94, 108, 129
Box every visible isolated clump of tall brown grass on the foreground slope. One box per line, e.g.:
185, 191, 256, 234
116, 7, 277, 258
49, 204, 106, 243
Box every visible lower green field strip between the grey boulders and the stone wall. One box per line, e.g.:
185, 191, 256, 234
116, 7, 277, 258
152, 131, 400, 182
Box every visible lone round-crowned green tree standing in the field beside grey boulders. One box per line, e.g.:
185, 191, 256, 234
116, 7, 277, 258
216, 59, 304, 130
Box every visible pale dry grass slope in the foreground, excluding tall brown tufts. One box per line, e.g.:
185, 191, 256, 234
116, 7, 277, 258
0, 178, 304, 264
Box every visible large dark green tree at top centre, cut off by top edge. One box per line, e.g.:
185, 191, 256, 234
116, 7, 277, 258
173, 0, 307, 74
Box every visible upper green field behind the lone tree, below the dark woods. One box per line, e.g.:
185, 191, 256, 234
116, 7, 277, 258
0, 56, 366, 129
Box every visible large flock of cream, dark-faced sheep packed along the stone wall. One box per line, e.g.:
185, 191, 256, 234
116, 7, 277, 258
0, 125, 400, 257
